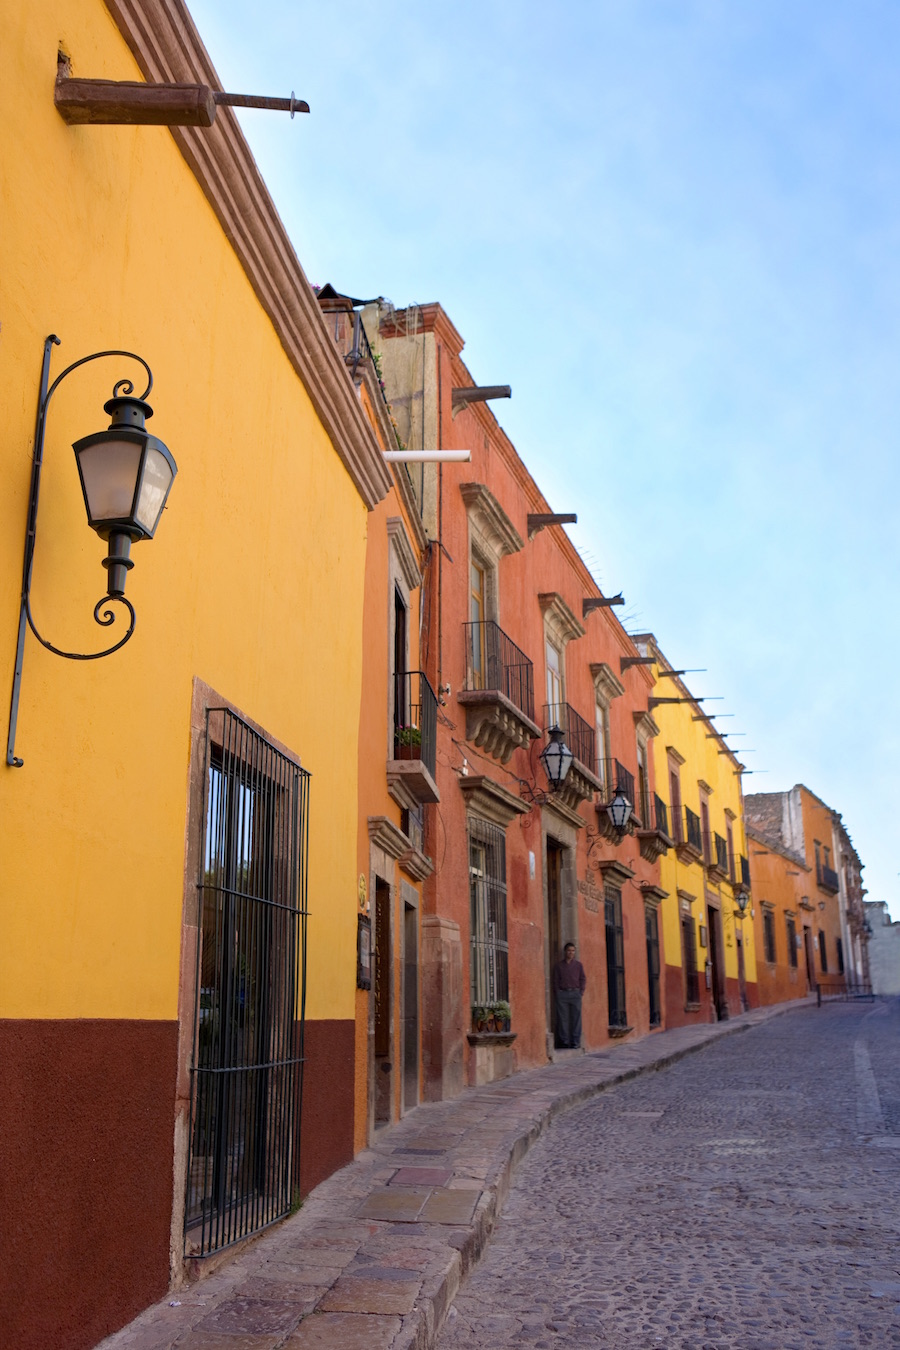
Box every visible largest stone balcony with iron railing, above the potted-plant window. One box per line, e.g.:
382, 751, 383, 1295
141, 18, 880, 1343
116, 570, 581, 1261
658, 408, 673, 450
457, 620, 541, 764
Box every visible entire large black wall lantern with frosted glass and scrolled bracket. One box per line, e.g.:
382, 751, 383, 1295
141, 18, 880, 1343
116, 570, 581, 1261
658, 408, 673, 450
7, 333, 178, 768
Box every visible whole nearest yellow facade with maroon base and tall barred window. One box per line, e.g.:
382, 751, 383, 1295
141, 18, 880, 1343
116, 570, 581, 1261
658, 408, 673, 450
0, 0, 391, 1350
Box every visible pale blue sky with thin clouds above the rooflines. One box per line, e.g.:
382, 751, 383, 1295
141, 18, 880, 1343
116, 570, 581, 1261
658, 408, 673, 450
189, 0, 900, 917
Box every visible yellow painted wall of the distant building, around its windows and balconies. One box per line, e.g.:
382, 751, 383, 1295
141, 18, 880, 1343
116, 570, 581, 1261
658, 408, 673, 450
653, 667, 757, 983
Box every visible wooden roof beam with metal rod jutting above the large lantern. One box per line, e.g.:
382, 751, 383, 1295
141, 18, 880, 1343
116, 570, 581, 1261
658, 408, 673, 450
54, 78, 309, 127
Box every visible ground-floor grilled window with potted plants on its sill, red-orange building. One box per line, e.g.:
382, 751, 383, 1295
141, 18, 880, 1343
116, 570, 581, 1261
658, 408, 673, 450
468, 819, 509, 1007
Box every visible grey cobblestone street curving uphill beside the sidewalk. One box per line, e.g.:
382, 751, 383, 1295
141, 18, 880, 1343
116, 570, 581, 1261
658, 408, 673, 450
439, 1000, 900, 1350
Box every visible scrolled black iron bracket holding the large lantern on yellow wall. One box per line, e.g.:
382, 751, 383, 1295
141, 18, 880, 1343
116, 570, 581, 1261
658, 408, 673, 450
7, 333, 175, 768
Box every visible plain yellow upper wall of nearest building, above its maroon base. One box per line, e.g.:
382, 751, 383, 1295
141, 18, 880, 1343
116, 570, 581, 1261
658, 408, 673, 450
0, 0, 367, 1019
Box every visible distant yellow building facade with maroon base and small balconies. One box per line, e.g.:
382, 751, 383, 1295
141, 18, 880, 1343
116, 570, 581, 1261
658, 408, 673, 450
637, 633, 758, 1027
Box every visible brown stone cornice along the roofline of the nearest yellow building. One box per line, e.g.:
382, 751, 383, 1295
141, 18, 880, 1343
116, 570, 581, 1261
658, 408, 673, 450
100, 0, 393, 510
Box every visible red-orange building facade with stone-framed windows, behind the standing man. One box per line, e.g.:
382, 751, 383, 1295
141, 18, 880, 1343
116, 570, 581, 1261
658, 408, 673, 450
364, 305, 674, 1099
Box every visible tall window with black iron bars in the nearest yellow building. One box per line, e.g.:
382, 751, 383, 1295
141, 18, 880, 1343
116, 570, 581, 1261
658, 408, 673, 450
185, 709, 309, 1256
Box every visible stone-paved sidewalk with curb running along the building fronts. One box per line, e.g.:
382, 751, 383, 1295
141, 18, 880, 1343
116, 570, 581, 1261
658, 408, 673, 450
101, 999, 812, 1350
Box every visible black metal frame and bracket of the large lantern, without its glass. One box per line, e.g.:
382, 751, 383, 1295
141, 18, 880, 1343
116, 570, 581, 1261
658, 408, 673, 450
7, 333, 177, 768
